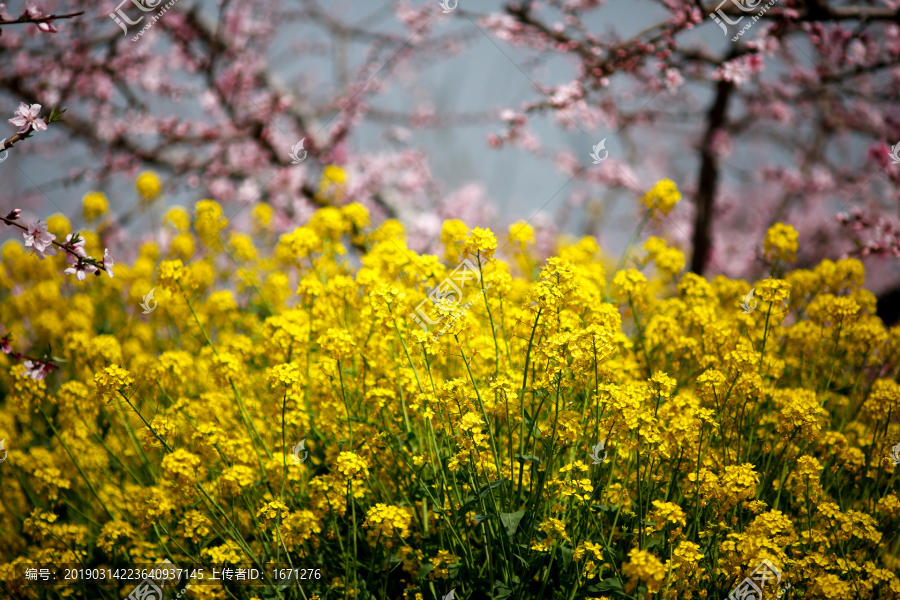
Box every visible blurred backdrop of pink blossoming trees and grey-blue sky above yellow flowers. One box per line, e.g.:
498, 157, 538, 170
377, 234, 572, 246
0, 0, 900, 320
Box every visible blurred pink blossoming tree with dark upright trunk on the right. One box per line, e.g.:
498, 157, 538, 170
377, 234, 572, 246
480, 1, 900, 289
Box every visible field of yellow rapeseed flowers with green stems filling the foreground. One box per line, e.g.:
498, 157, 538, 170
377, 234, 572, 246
0, 184, 900, 600
